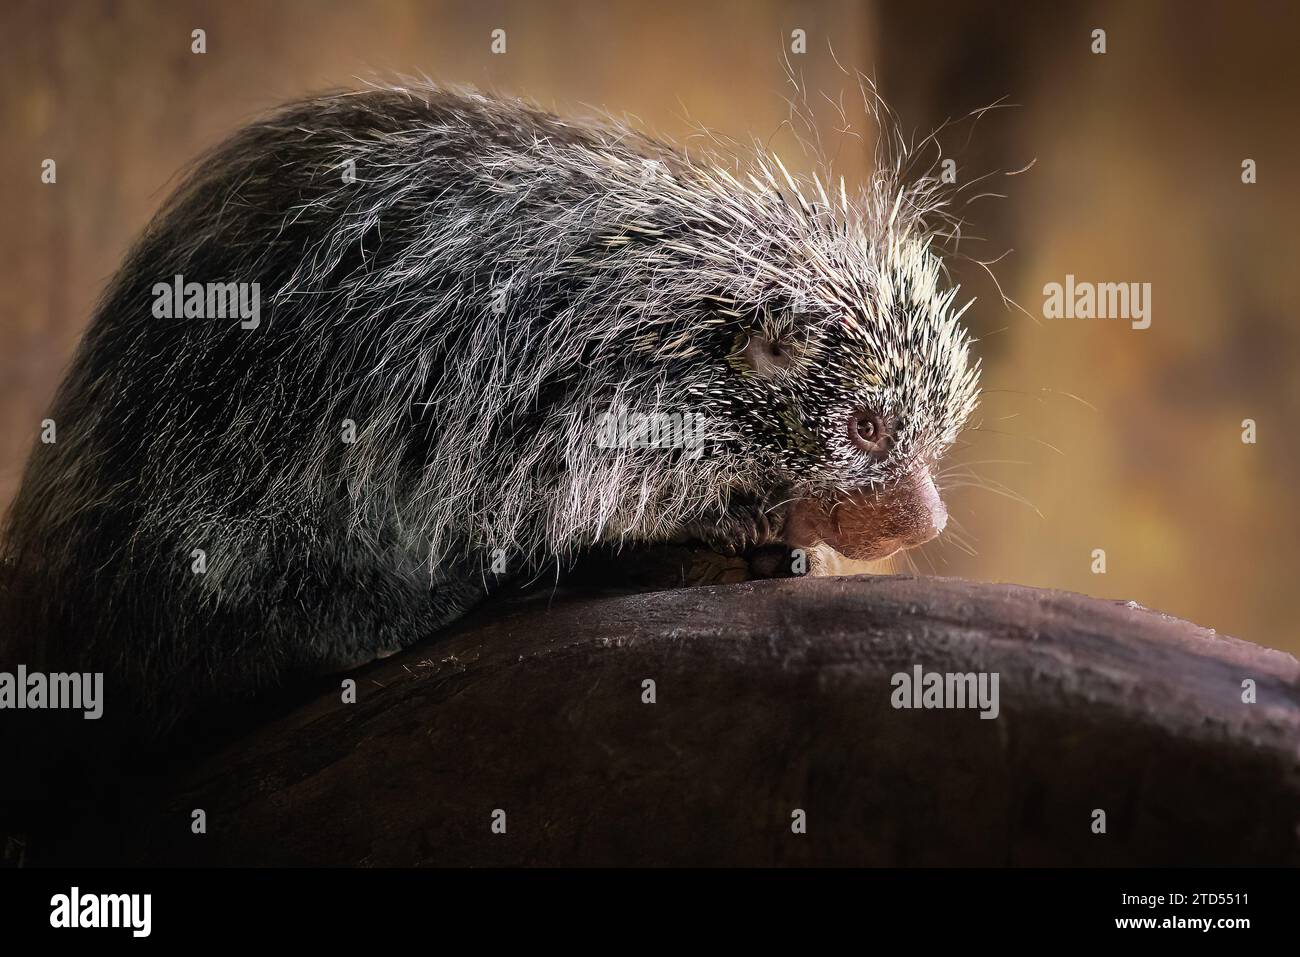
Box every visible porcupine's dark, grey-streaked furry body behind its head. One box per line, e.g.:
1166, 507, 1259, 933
5, 90, 722, 719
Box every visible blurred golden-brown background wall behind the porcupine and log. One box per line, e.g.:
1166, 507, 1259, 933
0, 0, 1300, 651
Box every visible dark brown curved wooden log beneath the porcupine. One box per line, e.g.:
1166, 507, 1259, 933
114, 577, 1300, 865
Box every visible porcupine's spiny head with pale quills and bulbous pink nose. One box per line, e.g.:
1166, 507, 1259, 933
590, 144, 979, 560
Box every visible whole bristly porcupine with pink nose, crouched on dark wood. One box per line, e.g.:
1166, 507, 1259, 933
5, 87, 979, 724
